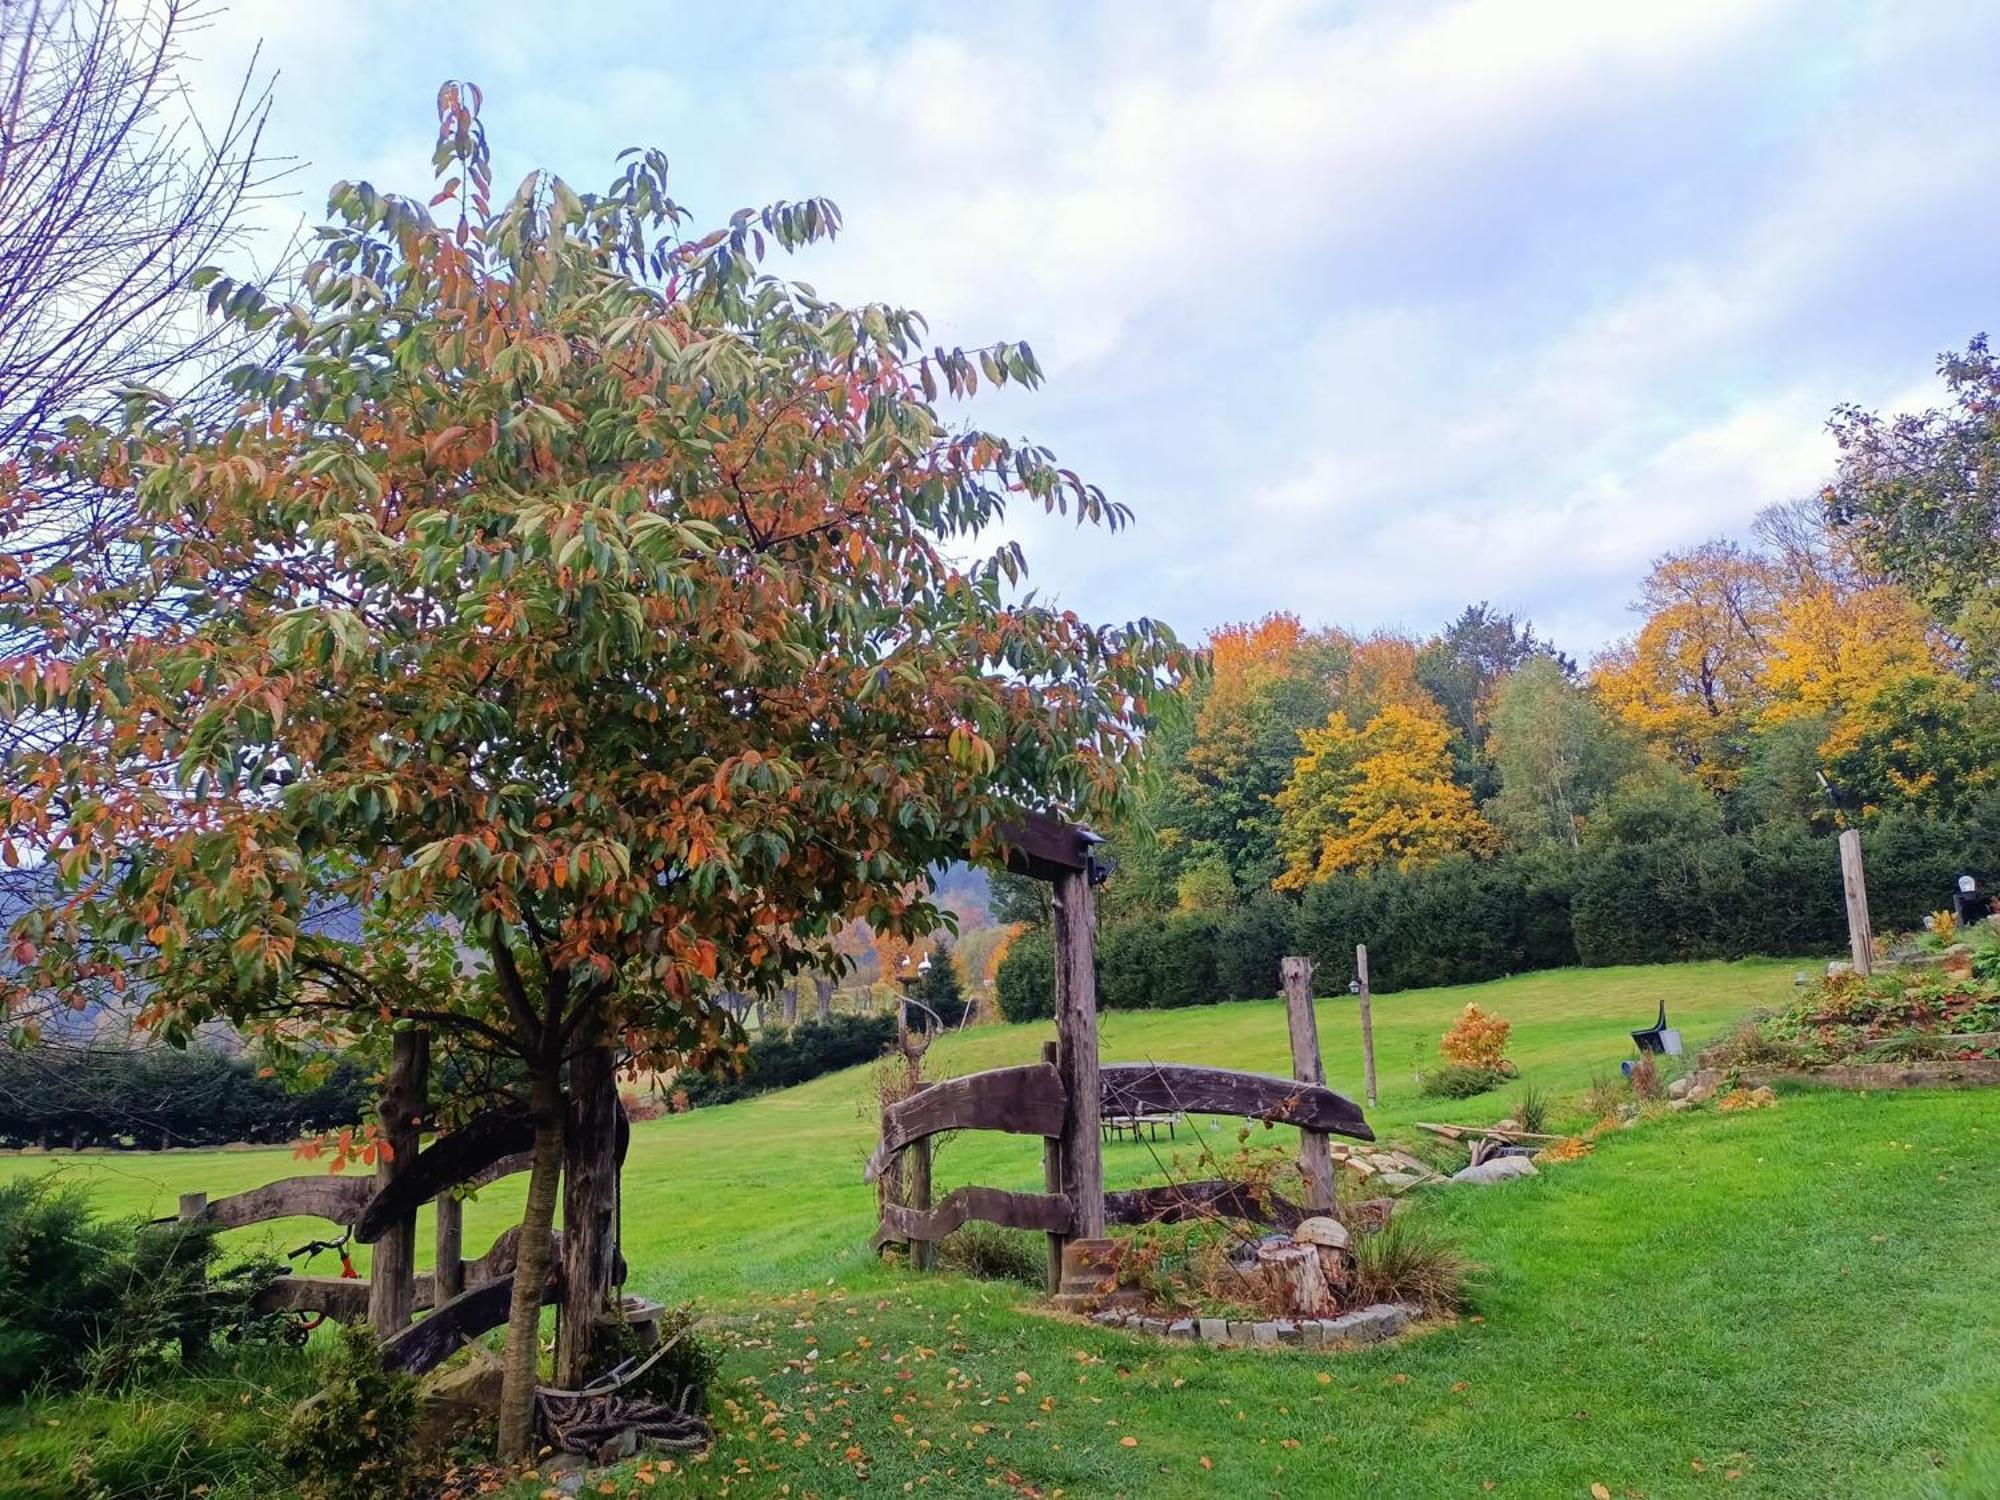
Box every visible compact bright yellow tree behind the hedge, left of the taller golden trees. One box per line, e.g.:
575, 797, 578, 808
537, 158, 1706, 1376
1274, 704, 1500, 890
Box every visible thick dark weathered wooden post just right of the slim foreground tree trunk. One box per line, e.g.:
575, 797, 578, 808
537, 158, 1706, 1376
556, 1032, 618, 1390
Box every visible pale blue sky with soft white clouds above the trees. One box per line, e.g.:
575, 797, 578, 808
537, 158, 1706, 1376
176, 0, 2000, 656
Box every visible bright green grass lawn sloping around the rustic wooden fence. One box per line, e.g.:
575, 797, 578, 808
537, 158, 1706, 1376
0, 962, 2000, 1498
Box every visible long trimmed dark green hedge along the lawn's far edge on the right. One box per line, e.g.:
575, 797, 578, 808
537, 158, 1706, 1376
996, 818, 2000, 1020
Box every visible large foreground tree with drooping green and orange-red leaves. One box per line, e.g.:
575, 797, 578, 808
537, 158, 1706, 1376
0, 86, 1186, 1456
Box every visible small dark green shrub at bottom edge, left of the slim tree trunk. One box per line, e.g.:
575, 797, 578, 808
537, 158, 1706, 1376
278, 1322, 428, 1500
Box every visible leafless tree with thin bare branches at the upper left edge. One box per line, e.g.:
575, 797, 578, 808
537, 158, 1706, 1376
0, 0, 276, 1048
